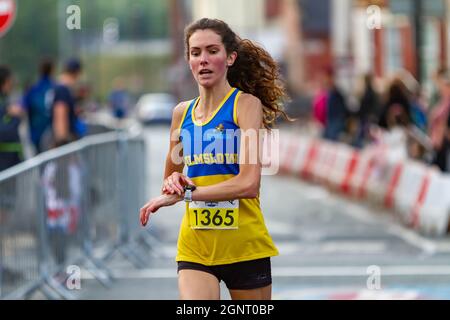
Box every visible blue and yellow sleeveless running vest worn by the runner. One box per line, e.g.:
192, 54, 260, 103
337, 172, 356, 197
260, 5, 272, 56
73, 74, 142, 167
176, 88, 278, 266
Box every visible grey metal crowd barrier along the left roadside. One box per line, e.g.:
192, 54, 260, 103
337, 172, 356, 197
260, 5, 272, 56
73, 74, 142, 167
0, 131, 152, 299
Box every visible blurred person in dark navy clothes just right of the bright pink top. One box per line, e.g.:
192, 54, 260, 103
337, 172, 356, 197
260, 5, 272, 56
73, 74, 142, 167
324, 68, 348, 141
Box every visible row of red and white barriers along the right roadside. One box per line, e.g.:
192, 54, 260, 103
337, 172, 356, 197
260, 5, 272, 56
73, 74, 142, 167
280, 134, 450, 235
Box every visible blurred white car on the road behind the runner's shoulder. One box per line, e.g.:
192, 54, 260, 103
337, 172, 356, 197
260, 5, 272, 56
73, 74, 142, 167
136, 93, 177, 124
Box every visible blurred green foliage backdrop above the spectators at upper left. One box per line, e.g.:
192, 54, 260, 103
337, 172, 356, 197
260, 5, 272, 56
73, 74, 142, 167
0, 0, 169, 84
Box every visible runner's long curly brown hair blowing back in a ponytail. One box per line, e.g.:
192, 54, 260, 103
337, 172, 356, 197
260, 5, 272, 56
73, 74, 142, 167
184, 18, 290, 128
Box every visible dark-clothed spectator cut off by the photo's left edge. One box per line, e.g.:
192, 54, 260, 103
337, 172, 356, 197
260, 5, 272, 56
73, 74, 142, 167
0, 66, 23, 171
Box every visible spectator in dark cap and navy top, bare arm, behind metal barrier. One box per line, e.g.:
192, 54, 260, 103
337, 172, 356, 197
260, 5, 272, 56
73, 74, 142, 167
47, 59, 82, 146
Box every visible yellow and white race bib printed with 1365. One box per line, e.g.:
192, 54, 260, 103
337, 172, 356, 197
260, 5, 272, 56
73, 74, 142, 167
189, 200, 239, 230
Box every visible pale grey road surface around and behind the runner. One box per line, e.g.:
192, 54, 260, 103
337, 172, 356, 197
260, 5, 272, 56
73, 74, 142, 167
77, 126, 450, 299
